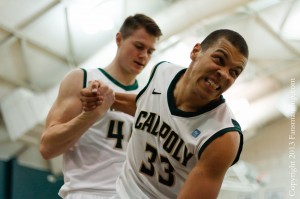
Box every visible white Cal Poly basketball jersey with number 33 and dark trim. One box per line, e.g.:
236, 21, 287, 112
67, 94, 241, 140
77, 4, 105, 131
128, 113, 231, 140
117, 62, 243, 199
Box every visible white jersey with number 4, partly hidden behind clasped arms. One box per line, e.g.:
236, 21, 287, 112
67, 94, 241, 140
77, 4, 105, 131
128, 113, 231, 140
59, 68, 139, 197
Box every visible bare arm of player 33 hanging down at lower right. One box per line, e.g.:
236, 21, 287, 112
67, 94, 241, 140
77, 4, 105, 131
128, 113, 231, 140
178, 132, 240, 199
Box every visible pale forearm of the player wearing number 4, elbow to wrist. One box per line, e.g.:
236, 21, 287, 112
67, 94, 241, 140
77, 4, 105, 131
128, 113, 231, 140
40, 112, 98, 159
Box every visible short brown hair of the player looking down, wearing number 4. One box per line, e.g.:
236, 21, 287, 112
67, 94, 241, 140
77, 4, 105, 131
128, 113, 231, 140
119, 14, 162, 39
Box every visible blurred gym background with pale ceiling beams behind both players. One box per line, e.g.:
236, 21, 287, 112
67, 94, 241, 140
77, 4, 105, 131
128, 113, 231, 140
0, 0, 300, 199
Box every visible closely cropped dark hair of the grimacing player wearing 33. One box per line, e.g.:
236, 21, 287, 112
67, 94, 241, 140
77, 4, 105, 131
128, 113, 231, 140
201, 29, 249, 58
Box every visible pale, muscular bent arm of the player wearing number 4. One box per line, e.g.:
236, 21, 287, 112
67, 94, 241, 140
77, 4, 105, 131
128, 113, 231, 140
40, 69, 111, 159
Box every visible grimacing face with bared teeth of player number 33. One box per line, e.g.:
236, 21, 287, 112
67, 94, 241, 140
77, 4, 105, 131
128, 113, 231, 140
191, 38, 247, 101
